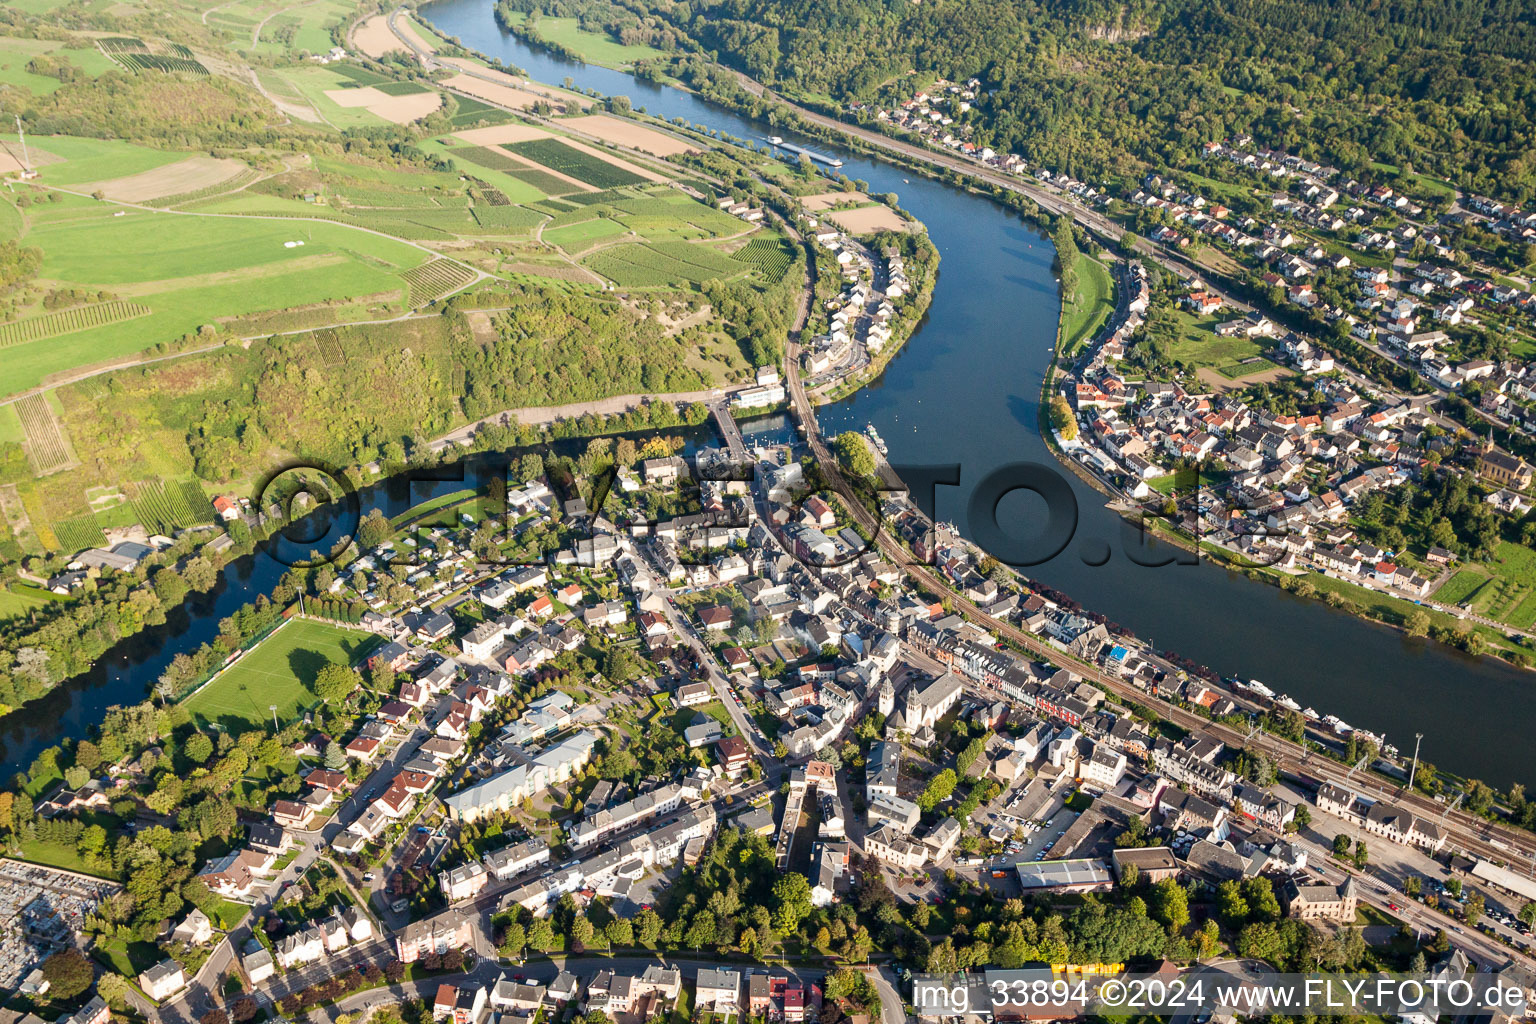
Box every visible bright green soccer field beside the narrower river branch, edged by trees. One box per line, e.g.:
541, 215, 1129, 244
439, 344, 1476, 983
186, 619, 379, 732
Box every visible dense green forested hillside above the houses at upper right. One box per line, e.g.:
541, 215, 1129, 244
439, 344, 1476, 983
559, 0, 1536, 198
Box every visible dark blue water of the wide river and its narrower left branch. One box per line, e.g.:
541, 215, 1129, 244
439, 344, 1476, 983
0, 8, 1517, 786
